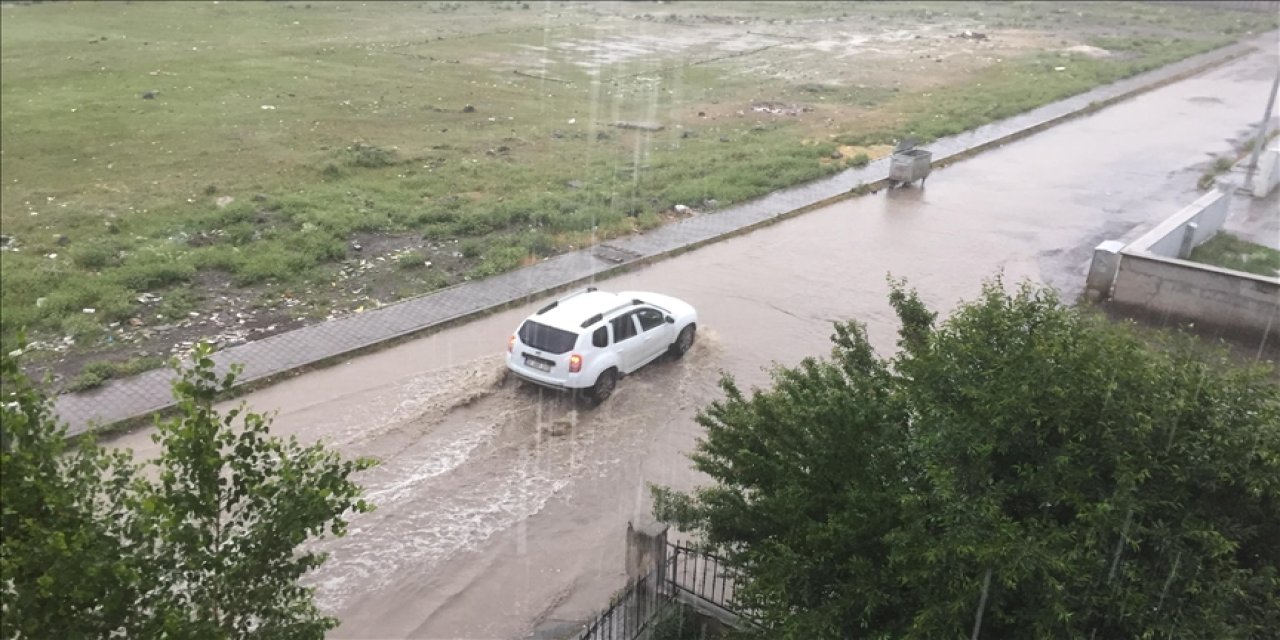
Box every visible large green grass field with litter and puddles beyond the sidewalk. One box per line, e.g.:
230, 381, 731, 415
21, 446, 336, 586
0, 1, 1276, 388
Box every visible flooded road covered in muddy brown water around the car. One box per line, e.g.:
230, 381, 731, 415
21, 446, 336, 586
116, 42, 1276, 639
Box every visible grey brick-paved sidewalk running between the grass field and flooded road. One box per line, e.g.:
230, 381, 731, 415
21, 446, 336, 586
54, 35, 1271, 435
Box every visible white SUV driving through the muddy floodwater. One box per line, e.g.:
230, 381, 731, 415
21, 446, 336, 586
507, 287, 698, 403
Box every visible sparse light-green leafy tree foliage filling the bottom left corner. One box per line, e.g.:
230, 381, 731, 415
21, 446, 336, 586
0, 344, 371, 639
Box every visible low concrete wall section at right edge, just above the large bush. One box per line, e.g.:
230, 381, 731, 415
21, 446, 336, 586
1111, 252, 1280, 342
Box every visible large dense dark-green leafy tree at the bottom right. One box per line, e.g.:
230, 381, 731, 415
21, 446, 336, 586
654, 280, 1280, 639
